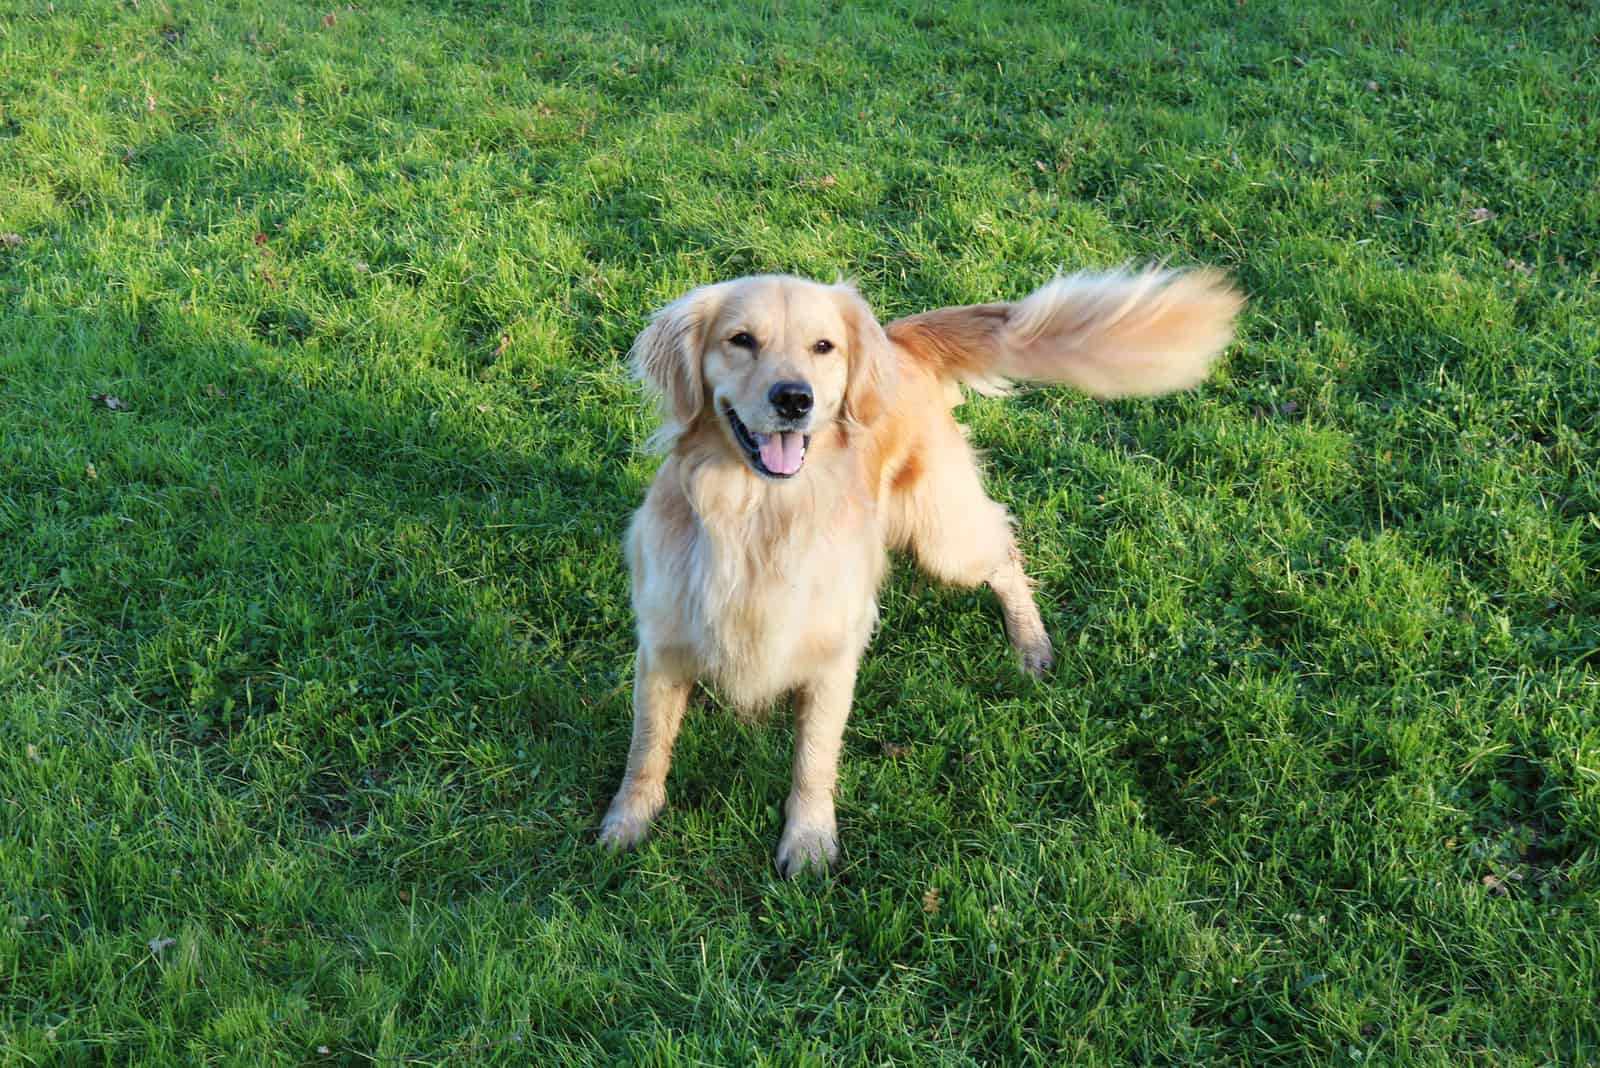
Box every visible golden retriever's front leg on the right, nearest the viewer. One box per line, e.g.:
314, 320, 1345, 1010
778, 656, 858, 878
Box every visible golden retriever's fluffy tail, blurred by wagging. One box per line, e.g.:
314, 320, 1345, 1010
885, 267, 1245, 398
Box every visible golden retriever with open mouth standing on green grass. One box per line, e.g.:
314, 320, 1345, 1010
600, 269, 1243, 876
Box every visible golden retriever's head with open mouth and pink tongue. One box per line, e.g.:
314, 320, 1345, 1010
634, 275, 894, 480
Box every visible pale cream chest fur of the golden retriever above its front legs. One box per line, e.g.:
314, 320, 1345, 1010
629, 457, 885, 711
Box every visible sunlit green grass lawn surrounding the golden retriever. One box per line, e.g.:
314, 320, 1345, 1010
0, 0, 1600, 1066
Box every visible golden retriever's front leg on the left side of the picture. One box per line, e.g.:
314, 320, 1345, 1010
600, 649, 693, 849
